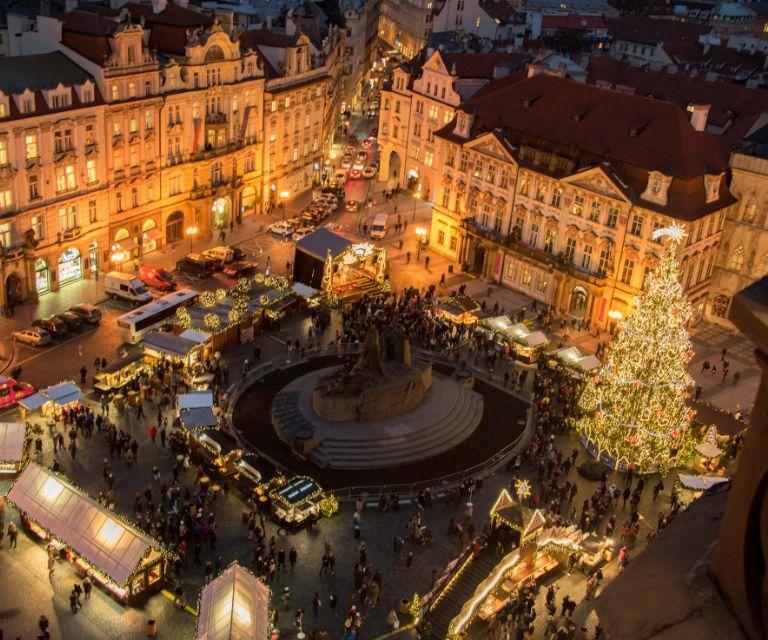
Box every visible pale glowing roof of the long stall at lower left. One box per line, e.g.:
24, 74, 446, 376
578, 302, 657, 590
8, 462, 160, 587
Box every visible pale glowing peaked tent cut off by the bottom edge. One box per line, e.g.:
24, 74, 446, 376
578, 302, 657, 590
195, 562, 269, 640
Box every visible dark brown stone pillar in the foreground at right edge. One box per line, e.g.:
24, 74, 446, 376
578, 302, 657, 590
710, 277, 768, 640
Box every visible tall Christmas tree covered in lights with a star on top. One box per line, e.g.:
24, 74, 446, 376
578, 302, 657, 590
576, 227, 694, 473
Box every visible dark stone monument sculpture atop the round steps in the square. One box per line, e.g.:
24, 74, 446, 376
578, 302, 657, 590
312, 328, 432, 422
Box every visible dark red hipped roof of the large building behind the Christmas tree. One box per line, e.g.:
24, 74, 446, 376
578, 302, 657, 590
438, 74, 733, 219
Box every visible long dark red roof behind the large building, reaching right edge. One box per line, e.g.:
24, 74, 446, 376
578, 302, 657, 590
587, 56, 768, 144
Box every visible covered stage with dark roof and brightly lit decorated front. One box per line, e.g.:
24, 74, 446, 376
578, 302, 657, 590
293, 227, 388, 300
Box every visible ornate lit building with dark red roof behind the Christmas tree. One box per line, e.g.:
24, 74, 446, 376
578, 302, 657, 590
430, 74, 734, 328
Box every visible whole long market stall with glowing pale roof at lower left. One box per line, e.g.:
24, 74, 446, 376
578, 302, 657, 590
7, 463, 170, 604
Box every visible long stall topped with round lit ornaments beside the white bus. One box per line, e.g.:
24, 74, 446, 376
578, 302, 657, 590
173, 273, 292, 352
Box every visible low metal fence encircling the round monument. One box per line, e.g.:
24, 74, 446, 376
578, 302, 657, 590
222, 343, 536, 502
